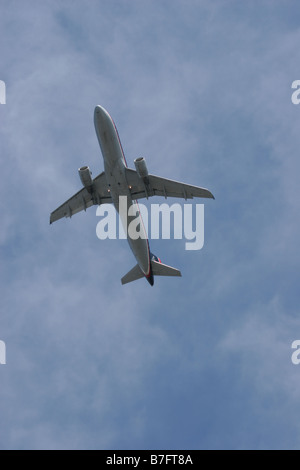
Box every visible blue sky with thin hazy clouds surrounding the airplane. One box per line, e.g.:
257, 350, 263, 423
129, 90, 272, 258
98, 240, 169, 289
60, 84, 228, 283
0, 0, 300, 449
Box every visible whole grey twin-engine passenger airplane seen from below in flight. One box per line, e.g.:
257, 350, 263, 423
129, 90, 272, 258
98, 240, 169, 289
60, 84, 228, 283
50, 105, 214, 286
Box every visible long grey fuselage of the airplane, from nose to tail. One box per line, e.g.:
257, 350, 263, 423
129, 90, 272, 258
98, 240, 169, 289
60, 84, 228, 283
94, 106, 153, 285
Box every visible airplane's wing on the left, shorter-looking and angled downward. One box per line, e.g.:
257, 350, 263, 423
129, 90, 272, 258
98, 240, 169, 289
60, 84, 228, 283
50, 171, 112, 224
